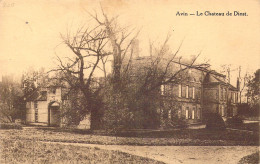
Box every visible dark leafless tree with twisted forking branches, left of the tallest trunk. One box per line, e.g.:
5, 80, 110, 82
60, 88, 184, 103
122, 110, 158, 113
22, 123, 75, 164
51, 22, 111, 128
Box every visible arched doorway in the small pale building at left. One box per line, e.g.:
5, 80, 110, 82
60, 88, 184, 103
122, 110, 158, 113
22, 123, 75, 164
48, 101, 60, 126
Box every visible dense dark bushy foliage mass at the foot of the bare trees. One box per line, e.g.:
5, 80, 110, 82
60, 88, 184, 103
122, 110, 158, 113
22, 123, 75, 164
103, 73, 160, 132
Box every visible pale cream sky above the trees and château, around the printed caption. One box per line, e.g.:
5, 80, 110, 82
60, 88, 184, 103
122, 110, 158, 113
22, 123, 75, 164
0, 0, 260, 86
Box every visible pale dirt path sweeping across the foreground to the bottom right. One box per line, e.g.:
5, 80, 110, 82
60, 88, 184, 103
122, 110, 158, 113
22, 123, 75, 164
42, 142, 258, 164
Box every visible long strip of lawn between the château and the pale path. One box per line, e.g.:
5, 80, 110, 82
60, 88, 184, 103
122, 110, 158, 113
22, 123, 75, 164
0, 128, 259, 146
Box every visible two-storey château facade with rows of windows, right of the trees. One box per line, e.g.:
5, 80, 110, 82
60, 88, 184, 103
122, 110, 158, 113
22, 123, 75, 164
161, 66, 238, 123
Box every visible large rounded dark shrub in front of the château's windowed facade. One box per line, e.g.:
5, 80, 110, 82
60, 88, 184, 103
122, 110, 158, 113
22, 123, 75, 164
203, 113, 226, 129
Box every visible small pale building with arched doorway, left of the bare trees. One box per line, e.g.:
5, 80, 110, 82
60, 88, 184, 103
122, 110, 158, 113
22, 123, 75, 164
26, 86, 90, 129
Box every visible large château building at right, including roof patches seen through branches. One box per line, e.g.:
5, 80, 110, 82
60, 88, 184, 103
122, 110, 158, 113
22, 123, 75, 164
127, 57, 238, 126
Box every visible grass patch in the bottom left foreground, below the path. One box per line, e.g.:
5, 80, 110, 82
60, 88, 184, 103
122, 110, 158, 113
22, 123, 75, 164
0, 139, 163, 164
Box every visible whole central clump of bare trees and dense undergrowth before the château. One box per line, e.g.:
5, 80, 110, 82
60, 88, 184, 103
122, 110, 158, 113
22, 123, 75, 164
52, 7, 209, 131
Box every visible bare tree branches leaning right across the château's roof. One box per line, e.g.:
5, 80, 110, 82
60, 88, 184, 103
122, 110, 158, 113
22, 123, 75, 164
133, 35, 210, 96
